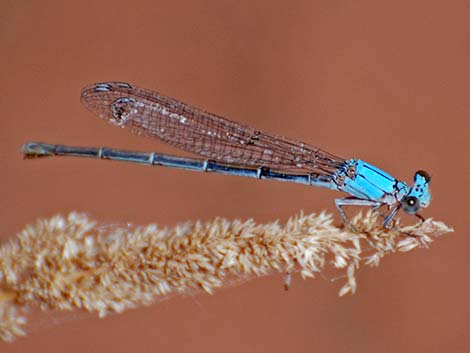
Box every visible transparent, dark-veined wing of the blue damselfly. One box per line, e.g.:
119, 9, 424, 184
81, 82, 345, 175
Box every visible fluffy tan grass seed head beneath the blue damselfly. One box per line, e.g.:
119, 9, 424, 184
0, 212, 452, 341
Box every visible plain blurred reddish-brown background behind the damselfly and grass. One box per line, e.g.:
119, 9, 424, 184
0, 0, 470, 352
